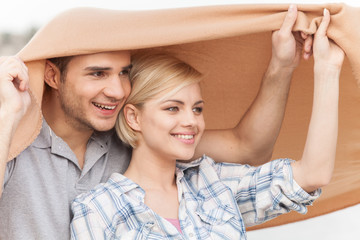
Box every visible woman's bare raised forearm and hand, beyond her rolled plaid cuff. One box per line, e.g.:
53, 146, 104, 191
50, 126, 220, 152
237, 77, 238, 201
292, 9, 344, 192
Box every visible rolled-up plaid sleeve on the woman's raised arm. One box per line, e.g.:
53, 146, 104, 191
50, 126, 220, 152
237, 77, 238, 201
211, 159, 321, 226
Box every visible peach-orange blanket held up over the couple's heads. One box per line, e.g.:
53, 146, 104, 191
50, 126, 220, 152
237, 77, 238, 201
9, 4, 360, 229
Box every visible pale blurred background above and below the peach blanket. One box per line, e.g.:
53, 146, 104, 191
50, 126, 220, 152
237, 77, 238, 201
0, 0, 360, 240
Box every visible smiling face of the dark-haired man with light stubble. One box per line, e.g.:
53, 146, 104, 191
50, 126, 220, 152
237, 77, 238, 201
59, 51, 130, 131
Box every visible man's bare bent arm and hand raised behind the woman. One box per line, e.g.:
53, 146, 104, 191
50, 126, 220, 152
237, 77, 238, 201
195, 5, 312, 165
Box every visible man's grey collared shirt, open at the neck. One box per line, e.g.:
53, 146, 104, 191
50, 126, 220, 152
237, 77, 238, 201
0, 121, 131, 240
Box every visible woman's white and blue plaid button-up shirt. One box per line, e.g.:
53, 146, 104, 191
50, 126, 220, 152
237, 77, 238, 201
71, 156, 320, 240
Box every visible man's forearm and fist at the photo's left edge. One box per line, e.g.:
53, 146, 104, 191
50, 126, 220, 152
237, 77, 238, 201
0, 57, 30, 196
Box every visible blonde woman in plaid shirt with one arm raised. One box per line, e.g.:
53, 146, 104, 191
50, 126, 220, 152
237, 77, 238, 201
71, 8, 344, 240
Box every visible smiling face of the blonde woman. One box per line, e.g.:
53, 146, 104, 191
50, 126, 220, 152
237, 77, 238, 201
138, 83, 205, 160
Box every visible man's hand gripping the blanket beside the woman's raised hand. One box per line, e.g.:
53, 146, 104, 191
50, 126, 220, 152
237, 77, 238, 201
271, 5, 312, 70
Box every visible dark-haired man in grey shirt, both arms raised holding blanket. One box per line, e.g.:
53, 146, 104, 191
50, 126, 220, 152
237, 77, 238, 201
0, 4, 312, 239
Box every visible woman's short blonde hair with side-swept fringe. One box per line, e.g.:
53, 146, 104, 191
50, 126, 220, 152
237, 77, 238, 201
115, 52, 202, 148
